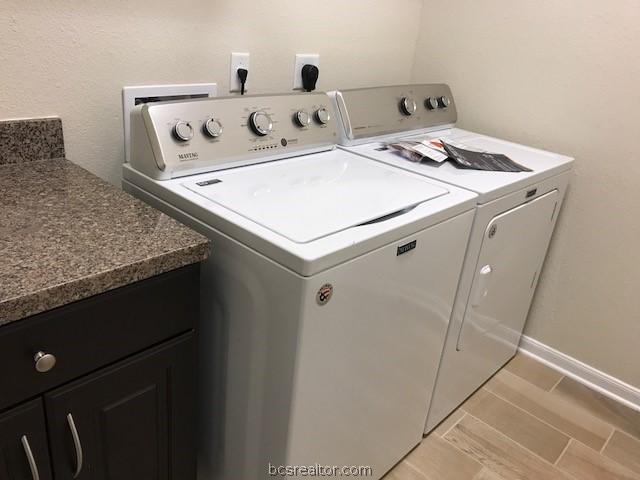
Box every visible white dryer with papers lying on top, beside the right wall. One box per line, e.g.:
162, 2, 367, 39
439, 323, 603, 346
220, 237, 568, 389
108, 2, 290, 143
330, 84, 573, 433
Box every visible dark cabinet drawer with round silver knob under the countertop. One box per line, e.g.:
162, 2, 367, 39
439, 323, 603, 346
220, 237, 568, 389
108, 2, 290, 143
0, 264, 200, 409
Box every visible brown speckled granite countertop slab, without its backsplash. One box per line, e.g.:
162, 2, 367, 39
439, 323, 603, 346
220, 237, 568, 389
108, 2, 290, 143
0, 159, 209, 325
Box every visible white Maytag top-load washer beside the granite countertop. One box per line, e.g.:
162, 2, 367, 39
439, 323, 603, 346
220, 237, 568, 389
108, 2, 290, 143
123, 93, 476, 480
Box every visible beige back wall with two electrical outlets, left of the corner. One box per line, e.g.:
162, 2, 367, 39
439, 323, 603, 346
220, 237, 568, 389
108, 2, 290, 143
0, 0, 422, 184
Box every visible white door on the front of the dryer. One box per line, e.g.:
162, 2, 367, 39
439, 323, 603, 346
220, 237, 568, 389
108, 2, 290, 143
457, 190, 559, 358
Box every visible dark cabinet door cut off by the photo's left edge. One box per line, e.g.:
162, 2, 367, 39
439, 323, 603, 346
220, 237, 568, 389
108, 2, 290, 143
0, 399, 51, 480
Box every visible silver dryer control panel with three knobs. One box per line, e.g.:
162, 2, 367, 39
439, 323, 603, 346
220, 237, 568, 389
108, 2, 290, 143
329, 83, 457, 145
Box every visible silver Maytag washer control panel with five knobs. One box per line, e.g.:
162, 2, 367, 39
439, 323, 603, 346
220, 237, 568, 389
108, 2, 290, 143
131, 93, 338, 180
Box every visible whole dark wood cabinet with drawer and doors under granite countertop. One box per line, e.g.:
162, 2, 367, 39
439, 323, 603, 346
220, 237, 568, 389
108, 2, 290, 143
0, 265, 199, 480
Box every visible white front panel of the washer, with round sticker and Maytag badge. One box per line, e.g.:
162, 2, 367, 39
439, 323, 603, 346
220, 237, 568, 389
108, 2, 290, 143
287, 212, 473, 479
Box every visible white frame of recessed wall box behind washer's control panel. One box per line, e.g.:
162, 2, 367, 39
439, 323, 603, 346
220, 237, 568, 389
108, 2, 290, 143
122, 83, 218, 163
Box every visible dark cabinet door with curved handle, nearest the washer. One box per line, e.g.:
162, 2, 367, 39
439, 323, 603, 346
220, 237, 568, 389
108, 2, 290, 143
45, 333, 195, 480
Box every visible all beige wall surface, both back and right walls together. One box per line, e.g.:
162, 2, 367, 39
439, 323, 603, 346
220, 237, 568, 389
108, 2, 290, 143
0, 0, 640, 387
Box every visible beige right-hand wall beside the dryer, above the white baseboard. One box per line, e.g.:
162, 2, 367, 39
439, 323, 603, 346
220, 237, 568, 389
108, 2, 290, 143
413, 0, 640, 387
